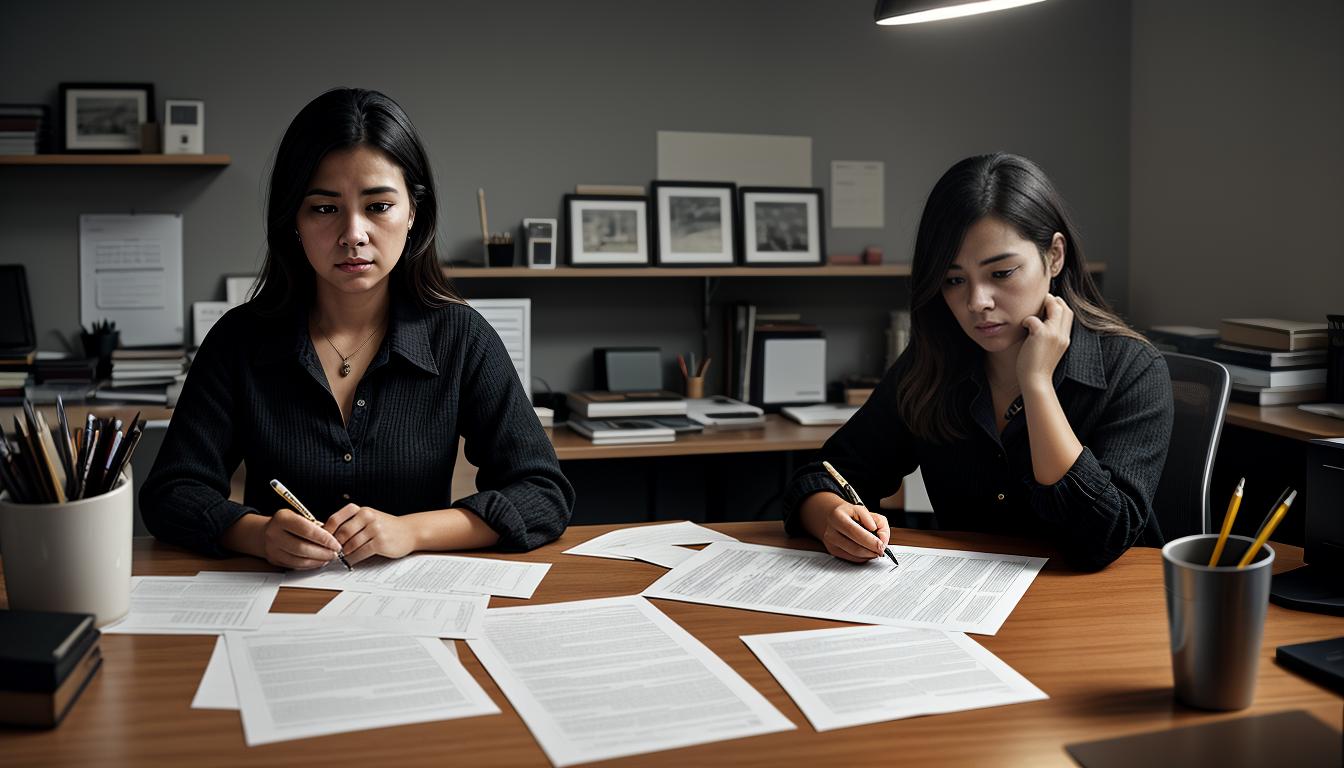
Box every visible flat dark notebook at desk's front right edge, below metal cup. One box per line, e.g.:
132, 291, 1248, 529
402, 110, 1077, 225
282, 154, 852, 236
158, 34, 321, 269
1064, 709, 1341, 768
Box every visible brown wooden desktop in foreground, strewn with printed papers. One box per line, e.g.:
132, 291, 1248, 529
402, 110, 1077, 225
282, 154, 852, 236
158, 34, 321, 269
0, 522, 1344, 768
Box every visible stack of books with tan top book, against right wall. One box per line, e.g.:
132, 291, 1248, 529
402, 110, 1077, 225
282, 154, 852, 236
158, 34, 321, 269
1203, 317, 1327, 406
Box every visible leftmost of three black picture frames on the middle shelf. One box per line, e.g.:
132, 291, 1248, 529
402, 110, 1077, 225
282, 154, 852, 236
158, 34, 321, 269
564, 195, 649, 266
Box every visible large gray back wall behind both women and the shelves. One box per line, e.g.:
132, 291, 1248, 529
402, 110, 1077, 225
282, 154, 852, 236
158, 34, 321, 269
0, 0, 1130, 389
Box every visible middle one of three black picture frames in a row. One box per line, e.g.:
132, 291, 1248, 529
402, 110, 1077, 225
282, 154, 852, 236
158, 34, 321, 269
649, 180, 738, 266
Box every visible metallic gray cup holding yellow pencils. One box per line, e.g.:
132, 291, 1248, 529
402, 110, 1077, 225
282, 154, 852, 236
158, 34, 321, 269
1163, 534, 1274, 710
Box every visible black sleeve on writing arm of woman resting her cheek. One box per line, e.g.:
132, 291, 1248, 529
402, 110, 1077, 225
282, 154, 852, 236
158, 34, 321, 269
784, 356, 918, 535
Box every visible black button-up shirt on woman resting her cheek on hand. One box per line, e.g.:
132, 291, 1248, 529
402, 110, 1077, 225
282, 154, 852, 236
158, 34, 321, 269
785, 320, 1173, 569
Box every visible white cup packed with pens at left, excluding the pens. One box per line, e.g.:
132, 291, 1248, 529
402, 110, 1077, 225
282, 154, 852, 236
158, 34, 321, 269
0, 469, 133, 627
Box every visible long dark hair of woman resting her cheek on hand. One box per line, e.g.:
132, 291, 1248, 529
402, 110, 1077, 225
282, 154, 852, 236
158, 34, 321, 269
896, 153, 1144, 443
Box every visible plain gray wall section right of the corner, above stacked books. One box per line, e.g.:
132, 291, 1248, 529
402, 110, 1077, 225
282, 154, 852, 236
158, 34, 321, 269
1129, 0, 1344, 327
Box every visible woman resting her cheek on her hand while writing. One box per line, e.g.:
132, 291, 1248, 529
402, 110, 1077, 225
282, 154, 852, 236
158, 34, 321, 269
785, 153, 1172, 569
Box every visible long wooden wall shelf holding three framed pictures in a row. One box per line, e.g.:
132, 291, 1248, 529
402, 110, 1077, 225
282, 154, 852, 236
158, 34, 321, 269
444, 262, 1106, 280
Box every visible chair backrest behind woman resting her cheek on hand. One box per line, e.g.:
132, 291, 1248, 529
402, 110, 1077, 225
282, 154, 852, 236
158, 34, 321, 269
1153, 352, 1231, 541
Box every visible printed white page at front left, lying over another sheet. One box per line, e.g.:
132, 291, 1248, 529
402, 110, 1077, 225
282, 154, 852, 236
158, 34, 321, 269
224, 628, 500, 746
